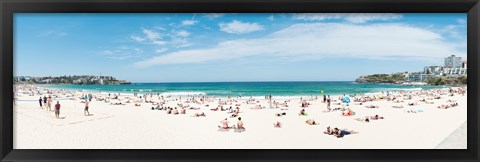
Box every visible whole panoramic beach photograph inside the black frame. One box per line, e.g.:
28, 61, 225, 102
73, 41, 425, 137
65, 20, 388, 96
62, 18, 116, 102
12, 13, 468, 149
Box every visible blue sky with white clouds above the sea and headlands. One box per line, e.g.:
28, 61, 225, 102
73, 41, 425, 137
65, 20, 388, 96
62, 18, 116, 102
14, 13, 467, 82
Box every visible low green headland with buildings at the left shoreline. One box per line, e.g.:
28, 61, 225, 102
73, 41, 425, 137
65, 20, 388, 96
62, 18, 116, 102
14, 75, 130, 85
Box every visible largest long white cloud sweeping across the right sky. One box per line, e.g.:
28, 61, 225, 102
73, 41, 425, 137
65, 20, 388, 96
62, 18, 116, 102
135, 23, 464, 67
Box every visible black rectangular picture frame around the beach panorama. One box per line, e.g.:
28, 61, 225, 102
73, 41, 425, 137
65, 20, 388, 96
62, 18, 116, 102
0, 0, 480, 161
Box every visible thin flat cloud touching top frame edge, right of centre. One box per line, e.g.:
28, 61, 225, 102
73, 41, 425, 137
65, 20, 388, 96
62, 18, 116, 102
293, 13, 403, 23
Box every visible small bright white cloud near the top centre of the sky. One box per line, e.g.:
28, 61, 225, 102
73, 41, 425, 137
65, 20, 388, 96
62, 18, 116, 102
219, 20, 264, 34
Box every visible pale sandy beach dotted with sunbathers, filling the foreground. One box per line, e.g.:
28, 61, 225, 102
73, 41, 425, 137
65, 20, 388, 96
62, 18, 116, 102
13, 86, 467, 149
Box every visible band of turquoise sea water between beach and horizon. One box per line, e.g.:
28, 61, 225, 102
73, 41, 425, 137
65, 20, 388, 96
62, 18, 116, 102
43, 81, 446, 96
